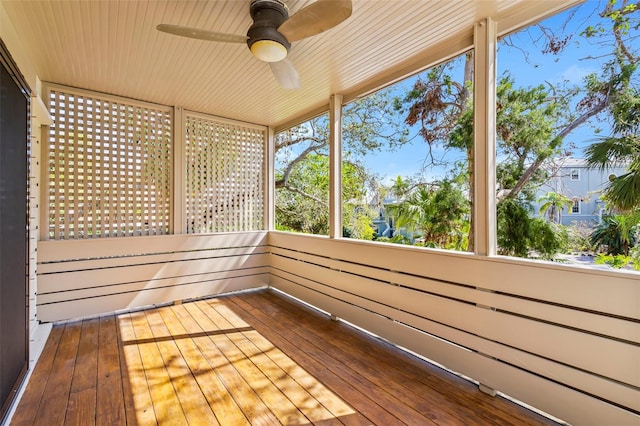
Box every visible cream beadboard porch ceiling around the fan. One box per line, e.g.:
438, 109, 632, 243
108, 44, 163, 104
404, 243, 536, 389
0, 0, 576, 127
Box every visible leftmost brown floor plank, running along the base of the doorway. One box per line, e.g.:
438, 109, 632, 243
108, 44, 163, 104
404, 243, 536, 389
11, 327, 64, 426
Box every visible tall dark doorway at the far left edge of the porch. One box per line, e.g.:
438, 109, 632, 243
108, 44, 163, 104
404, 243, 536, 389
0, 40, 30, 422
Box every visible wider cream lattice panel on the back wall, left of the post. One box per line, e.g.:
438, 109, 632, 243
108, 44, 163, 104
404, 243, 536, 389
47, 90, 172, 239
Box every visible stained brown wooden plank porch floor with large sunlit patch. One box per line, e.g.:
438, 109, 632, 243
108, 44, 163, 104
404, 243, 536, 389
11, 290, 552, 426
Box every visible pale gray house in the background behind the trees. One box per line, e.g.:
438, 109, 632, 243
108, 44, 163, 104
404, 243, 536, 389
534, 158, 626, 225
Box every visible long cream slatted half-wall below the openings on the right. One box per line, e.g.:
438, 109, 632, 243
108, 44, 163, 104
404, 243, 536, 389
269, 232, 640, 425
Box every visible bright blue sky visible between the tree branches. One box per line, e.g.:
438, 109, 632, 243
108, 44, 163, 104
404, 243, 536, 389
356, 0, 636, 183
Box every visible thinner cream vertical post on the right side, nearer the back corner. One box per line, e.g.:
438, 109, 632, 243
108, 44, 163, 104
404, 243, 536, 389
329, 95, 342, 238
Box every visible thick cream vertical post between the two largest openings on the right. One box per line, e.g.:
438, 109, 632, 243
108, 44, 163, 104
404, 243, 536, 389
472, 18, 497, 256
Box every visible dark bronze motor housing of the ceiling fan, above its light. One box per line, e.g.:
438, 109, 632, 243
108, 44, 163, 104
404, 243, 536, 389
247, 0, 291, 51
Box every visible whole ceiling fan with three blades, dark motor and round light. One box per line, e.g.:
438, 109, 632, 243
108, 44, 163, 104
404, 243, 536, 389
156, 0, 352, 89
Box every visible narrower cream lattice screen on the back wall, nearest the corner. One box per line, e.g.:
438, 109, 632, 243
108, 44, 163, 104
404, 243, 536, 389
185, 114, 266, 233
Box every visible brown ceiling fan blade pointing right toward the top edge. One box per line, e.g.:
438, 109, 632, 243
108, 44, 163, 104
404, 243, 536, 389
278, 0, 352, 43
